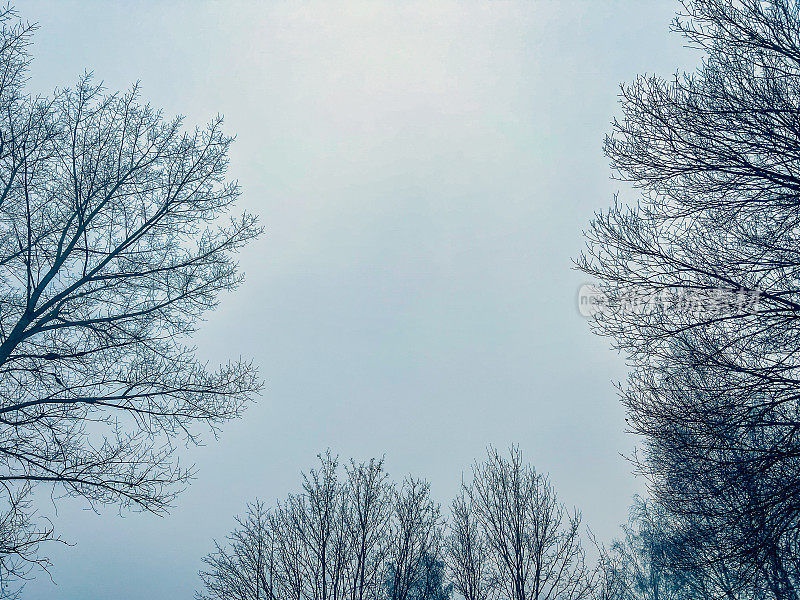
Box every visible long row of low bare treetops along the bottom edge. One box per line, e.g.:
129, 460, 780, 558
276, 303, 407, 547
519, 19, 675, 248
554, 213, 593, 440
197, 447, 772, 600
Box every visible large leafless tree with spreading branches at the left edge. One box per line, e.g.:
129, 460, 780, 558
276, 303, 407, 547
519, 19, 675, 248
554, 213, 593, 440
0, 3, 260, 584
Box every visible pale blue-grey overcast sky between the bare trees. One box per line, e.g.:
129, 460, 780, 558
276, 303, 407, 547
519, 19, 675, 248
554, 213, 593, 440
17, 0, 696, 600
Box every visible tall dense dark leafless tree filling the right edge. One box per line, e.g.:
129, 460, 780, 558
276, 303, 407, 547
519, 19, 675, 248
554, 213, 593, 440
579, 0, 800, 598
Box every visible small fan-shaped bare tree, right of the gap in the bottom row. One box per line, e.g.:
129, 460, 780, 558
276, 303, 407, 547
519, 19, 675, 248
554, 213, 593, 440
465, 447, 596, 600
